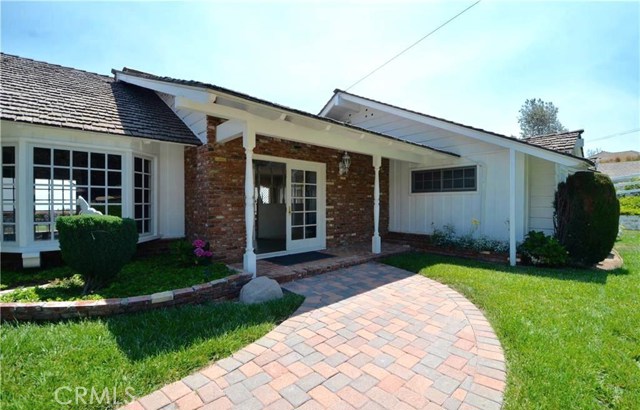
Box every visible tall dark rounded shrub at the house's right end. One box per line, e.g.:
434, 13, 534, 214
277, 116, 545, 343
554, 172, 620, 266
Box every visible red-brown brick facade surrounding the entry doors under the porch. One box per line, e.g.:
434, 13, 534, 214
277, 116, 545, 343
185, 118, 389, 261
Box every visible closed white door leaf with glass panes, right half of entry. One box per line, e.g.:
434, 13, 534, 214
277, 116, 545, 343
286, 160, 326, 253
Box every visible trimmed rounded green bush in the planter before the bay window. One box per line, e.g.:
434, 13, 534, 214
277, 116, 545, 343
56, 215, 138, 294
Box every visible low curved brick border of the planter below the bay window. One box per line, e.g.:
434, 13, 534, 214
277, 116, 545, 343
0, 272, 251, 321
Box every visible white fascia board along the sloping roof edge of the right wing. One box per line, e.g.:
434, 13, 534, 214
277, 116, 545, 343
341, 94, 585, 166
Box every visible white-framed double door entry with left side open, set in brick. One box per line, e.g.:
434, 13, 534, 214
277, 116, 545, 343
253, 155, 326, 257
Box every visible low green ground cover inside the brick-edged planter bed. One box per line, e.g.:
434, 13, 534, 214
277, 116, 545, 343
0, 255, 234, 302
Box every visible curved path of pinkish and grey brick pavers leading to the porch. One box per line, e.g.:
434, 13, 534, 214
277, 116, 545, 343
127, 263, 505, 410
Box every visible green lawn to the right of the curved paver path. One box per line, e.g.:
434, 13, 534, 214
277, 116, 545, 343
385, 231, 640, 409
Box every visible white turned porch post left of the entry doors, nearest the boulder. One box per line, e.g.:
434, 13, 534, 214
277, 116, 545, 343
242, 123, 257, 278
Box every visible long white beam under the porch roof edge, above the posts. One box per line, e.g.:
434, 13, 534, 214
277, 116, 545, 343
175, 97, 451, 164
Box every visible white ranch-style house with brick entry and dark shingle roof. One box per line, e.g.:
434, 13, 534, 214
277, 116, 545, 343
0, 54, 593, 273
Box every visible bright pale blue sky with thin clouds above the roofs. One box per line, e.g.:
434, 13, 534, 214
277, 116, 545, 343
0, 0, 640, 152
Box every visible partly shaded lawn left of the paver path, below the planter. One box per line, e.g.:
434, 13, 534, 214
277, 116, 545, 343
0, 293, 304, 410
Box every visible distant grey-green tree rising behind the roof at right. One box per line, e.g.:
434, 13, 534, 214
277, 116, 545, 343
518, 98, 567, 138
